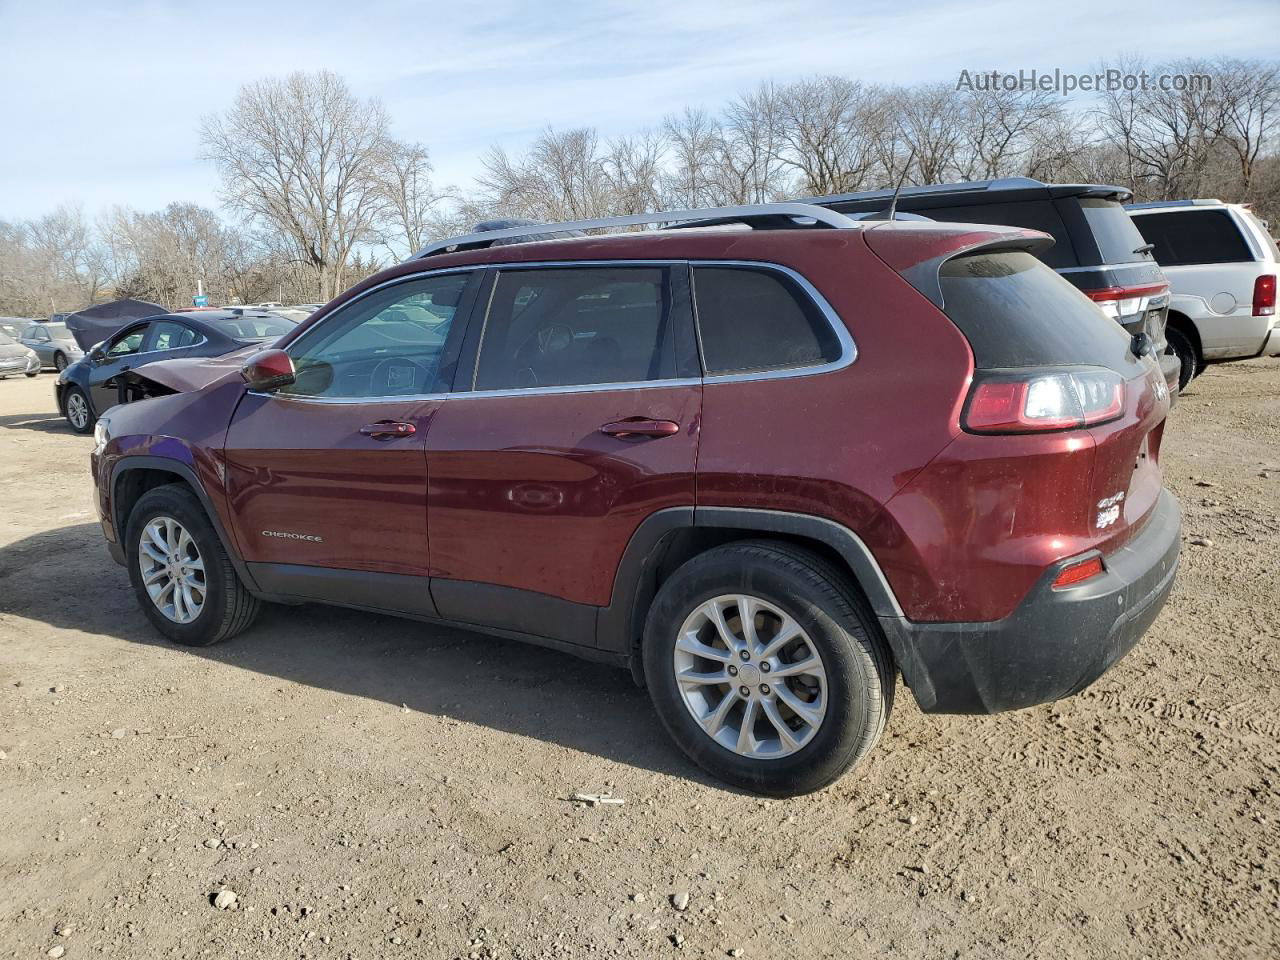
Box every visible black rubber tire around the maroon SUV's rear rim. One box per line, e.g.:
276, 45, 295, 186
643, 540, 896, 796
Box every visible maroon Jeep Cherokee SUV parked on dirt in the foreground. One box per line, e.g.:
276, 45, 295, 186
93, 205, 1180, 795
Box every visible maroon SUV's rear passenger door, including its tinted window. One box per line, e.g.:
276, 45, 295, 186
428, 264, 701, 644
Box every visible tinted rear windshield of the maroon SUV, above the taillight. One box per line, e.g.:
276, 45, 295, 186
938, 251, 1129, 370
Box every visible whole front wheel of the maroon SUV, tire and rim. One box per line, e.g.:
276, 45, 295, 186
125, 484, 260, 646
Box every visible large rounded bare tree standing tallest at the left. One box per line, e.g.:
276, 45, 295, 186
201, 70, 393, 298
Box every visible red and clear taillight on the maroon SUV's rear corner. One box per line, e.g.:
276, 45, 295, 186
963, 369, 1124, 434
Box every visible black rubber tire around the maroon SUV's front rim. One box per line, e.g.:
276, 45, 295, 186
125, 484, 261, 646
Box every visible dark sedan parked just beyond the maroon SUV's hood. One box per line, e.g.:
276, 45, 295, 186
54, 311, 293, 434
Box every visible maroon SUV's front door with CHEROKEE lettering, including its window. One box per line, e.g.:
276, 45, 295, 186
225, 273, 474, 614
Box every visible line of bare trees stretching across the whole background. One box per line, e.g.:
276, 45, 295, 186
0, 58, 1280, 316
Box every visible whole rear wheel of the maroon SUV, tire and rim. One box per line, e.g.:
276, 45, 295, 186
644, 541, 895, 796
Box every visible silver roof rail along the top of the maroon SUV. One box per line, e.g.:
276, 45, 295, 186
410, 204, 859, 260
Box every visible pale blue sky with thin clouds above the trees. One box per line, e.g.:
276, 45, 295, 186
0, 0, 1280, 219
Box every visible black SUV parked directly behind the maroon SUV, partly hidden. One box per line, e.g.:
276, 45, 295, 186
804, 177, 1180, 396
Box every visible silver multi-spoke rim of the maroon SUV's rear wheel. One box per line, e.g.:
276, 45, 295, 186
672, 594, 827, 760
